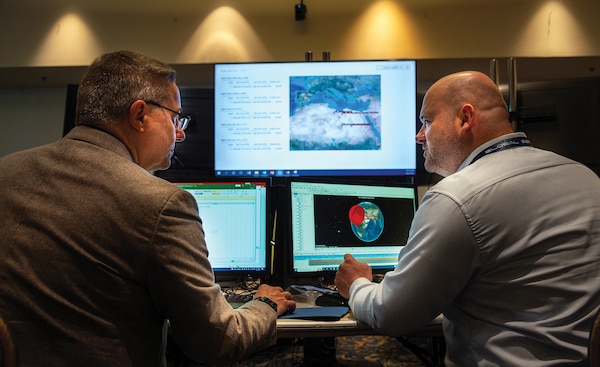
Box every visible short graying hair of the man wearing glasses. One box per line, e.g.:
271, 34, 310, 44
75, 51, 176, 126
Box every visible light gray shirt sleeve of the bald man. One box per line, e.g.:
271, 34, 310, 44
349, 192, 480, 336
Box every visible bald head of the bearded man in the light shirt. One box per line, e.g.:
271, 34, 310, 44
416, 71, 513, 176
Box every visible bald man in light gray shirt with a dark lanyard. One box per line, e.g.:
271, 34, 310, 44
335, 71, 600, 366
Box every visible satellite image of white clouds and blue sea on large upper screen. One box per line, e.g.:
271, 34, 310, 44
290, 75, 381, 150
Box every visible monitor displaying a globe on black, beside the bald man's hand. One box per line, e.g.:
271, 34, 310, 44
289, 181, 418, 278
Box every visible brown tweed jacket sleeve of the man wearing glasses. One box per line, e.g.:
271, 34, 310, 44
148, 191, 277, 364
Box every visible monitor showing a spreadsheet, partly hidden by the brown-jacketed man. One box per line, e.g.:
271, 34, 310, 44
176, 179, 270, 280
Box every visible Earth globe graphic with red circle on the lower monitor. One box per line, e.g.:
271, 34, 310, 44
348, 201, 384, 242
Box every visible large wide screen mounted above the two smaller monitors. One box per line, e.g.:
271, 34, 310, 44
214, 60, 416, 177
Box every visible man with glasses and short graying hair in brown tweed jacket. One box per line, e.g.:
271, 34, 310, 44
0, 51, 295, 367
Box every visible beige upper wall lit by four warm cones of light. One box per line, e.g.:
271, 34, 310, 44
0, 0, 600, 67
